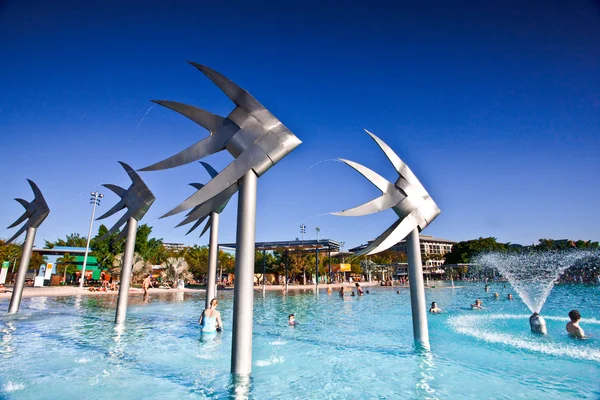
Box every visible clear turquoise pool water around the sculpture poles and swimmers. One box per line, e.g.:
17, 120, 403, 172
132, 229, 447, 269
0, 283, 600, 399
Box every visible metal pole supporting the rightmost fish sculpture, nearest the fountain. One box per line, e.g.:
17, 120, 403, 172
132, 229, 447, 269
406, 228, 429, 349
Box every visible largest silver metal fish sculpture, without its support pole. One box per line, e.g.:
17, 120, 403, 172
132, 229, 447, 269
141, 62, 302, 226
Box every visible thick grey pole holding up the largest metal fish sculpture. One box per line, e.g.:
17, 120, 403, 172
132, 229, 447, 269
231, 171, 258, 375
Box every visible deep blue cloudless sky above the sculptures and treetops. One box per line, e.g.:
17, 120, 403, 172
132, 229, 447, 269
0, 0, 600, 248
